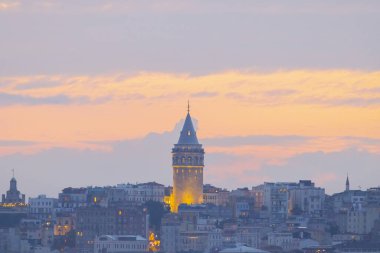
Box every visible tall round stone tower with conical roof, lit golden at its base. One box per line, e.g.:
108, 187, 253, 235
171, 104, 204, 212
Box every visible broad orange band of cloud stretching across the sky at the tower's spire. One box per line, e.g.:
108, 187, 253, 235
0, 70, 380, 150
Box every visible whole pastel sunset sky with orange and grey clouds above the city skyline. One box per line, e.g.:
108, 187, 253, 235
0, 0, 380, 197
